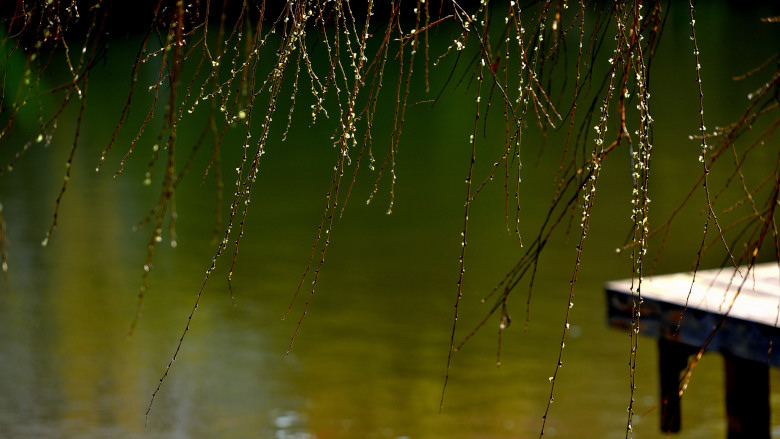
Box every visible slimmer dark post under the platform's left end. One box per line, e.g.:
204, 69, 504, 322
658, 338, 697, 432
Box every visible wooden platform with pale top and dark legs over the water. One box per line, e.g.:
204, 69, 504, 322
605, 263, 780, 439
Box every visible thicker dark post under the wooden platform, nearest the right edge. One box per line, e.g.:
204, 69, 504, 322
724, 355, 770, 439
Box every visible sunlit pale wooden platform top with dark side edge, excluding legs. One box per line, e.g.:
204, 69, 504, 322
605, 263, 780, 367
